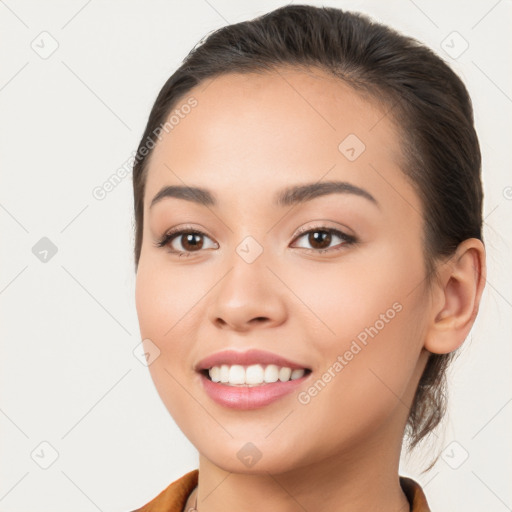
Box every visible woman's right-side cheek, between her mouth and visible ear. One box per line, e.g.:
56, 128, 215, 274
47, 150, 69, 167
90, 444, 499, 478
289, 244, 426, 418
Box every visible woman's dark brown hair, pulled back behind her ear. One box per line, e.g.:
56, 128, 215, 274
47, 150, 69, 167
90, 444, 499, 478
133, 5, 483, 469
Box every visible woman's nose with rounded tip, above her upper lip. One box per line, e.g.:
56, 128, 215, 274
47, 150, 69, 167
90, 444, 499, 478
208, 255, 287, 332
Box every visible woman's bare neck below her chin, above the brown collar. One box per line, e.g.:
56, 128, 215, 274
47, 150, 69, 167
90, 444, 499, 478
185, 416, 410, 512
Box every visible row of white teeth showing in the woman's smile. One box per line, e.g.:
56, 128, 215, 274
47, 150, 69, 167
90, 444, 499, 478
208, 364, 305, 386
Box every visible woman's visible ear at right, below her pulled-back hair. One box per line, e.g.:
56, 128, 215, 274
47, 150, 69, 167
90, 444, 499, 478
425, 238, 486, 354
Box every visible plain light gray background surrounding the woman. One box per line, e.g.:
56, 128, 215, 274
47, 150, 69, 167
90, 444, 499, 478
0, 0, 512, 512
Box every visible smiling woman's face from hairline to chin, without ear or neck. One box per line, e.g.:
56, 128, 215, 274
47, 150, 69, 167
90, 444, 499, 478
136, 70, 430, 473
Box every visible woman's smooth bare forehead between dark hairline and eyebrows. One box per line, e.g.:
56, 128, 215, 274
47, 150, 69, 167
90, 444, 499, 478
144, 69, 418, 214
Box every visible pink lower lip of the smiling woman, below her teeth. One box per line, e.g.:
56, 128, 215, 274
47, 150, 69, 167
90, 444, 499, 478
200, 372, 311, 410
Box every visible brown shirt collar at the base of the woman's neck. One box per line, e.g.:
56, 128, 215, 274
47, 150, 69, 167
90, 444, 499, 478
132, 469, 430, 512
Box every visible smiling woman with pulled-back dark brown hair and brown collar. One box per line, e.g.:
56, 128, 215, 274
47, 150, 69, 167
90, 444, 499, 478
128, 5, 485, 512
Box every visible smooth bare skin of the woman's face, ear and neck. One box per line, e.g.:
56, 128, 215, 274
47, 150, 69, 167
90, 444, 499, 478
136, 68, 485, 512
